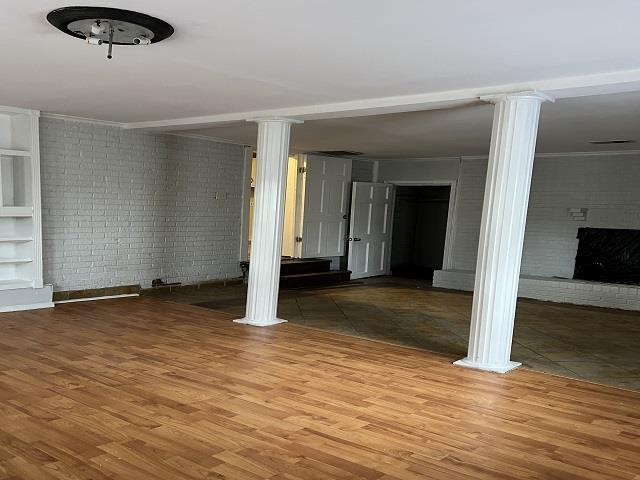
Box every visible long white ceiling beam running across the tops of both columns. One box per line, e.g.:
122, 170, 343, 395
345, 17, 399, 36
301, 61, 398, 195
124, 69, 640, 130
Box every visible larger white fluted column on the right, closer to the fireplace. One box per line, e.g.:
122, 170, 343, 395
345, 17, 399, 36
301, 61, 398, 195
455, 92, 550, 373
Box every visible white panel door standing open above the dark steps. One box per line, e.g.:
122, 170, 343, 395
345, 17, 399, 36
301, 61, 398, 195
302, 155, 351, 258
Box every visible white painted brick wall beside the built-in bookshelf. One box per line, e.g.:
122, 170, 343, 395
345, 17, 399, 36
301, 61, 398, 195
40, 118, 242, 290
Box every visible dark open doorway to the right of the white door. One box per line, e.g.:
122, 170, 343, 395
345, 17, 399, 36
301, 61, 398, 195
391, 186, 451, 280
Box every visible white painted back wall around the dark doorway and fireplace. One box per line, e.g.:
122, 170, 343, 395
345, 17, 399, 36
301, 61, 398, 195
379, 154, 640, 278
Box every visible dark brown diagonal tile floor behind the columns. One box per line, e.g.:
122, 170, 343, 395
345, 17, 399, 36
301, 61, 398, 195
146, 277, 640, 391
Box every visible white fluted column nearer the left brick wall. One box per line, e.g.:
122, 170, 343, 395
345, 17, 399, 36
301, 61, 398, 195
234, 118, 300, 327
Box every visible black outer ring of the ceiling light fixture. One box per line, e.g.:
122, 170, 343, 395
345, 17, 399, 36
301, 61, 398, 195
47, 7, 173, 45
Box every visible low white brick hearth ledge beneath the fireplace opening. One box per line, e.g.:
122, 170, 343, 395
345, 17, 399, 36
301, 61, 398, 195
433, 270, 640, 310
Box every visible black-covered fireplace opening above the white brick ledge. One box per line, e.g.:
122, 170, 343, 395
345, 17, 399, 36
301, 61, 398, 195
573, 228, 640, 285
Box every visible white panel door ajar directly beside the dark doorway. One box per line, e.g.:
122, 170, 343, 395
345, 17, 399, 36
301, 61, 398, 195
349, 182, 393, 278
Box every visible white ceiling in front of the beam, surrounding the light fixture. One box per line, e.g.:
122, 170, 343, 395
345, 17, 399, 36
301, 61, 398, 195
0, 0, 640, 124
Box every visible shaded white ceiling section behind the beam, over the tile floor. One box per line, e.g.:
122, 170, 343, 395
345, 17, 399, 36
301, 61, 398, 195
179, 92, 640, 158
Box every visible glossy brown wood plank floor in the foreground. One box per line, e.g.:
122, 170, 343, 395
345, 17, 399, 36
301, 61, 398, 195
0, 298, 640, 480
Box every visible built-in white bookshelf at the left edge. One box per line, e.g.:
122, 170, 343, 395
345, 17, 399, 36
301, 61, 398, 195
0, 107, 52, 312
